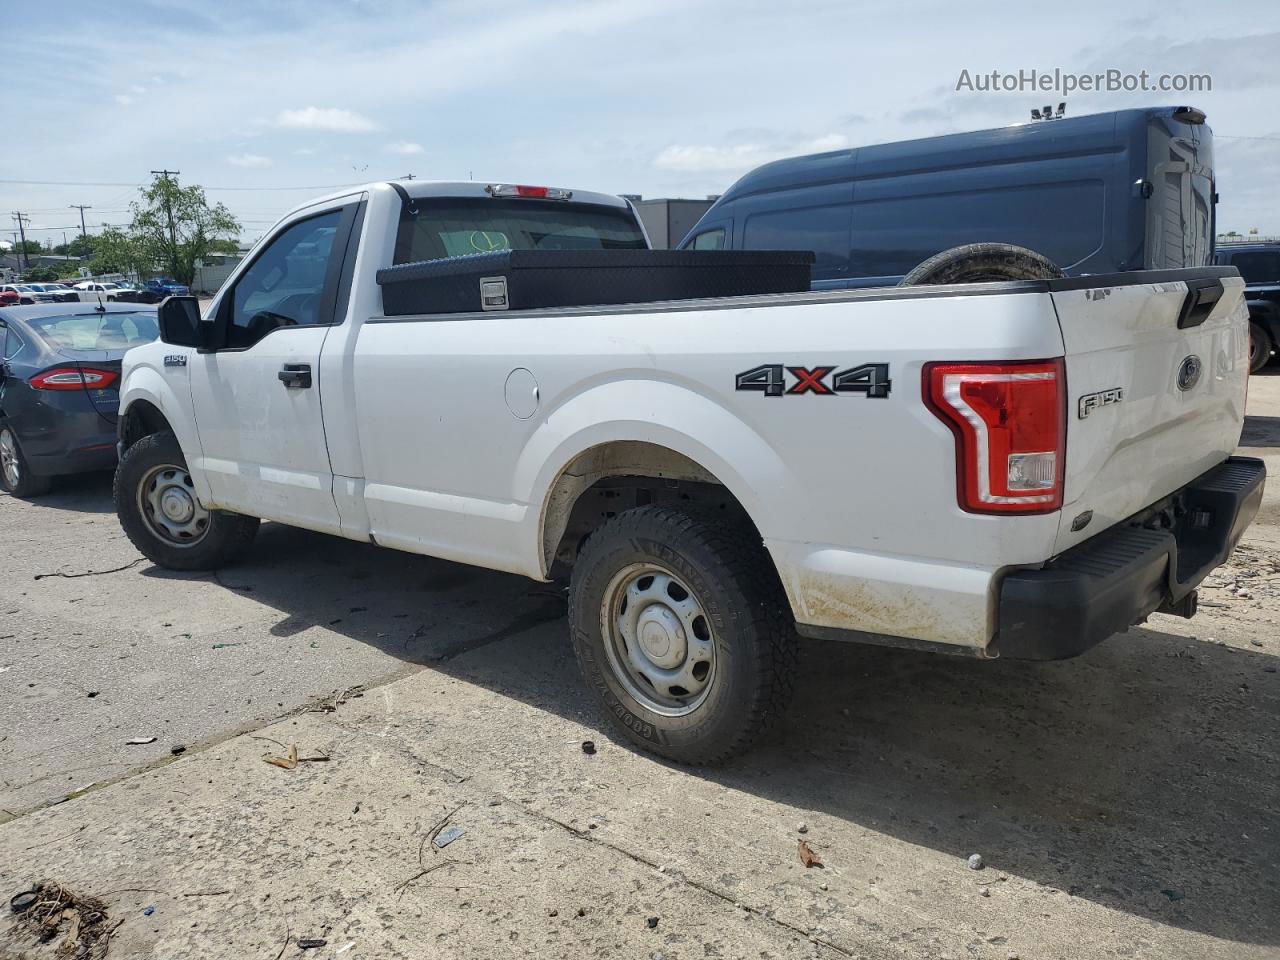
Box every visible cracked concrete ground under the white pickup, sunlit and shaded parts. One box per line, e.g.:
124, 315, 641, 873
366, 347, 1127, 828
0, 375, 1280, 960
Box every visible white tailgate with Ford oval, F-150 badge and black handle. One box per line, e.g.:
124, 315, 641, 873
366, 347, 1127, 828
1050, 266, 1249, 553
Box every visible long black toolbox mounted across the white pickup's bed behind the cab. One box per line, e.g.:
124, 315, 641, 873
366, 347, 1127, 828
378, 250, 814, 316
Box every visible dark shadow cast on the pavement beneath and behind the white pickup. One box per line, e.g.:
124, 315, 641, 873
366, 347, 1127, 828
55, 483, 1264, 945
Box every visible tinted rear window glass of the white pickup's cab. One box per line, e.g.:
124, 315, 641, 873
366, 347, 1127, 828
396, 197, 646, 264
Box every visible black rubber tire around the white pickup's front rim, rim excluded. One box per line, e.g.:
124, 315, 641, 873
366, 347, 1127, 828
113, 430, 259, 570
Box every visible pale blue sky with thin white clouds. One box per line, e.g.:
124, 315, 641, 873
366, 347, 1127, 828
0, 0, 1280, 242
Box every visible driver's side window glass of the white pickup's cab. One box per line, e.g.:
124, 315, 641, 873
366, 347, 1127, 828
227, 210, 342, 349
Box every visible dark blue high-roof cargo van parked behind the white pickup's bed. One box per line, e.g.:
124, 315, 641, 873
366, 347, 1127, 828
681, 106, 1216, 287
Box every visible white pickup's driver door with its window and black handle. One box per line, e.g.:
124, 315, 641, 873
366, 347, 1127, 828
187, 204, 360, 532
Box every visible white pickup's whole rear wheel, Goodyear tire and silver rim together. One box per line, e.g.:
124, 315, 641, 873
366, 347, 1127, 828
568, 506, 796, 764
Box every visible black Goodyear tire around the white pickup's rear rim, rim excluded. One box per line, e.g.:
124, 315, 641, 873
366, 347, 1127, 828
568, 506, 796, 765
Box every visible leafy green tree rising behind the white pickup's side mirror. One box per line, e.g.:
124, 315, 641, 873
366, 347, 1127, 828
129, 175, 241, 284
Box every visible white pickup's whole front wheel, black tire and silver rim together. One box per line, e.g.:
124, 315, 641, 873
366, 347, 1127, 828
114, 430, 259, 570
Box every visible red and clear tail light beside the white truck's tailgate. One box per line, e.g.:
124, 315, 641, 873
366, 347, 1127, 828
924, 358, 1066, 513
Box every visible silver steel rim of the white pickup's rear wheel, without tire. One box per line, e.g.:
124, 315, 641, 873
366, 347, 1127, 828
600, 563, 716, 717
